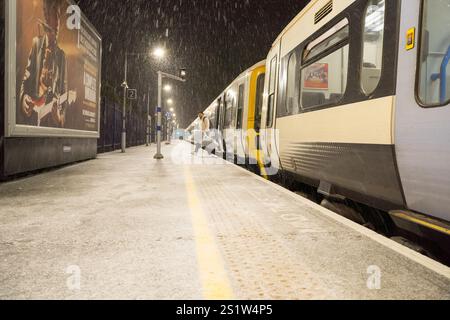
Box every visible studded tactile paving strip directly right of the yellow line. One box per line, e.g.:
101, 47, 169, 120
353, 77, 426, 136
193, 170, 333, 300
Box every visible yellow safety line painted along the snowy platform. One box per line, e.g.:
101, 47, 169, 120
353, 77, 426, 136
184, 167, 233, 300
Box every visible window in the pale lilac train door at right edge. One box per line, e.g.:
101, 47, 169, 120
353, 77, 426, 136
417, 0, 450, 107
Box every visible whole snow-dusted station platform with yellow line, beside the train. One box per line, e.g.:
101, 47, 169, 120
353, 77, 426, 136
0, 142, 450, 299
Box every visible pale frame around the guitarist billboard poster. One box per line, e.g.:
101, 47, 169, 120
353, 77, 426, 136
0, 0, 103, 139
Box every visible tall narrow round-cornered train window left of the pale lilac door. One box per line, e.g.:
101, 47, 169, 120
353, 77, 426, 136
361, 0, 385, 95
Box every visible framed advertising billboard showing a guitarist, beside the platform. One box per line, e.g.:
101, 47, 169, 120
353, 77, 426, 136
6, 0, 101, 138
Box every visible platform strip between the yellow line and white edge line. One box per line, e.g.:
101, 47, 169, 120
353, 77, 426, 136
186, 162, 450, 300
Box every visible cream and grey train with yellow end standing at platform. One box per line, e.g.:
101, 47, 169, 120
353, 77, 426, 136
188, 0, 450, 257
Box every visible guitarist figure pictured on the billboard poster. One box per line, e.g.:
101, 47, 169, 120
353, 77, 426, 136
20, 0, 69, 128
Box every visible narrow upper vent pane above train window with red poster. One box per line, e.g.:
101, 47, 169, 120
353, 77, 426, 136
303, 18, 350, 63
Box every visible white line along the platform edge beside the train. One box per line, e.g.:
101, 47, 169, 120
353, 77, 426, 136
232, 166, 450, 279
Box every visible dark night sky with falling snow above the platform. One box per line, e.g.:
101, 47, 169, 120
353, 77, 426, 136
77, 0, 308, 127
